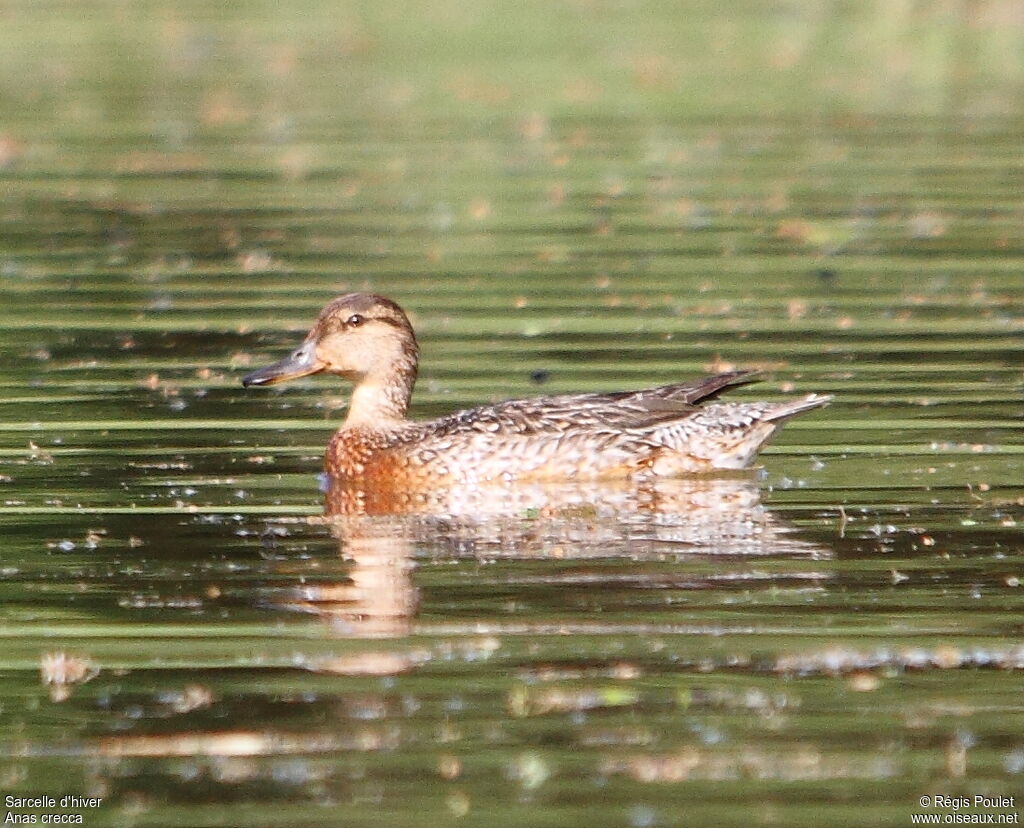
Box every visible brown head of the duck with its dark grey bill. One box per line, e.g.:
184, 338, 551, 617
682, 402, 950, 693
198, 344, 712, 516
242, 294, 419, 390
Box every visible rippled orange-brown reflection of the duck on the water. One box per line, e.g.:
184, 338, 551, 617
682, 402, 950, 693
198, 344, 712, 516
280, 474, 829, 638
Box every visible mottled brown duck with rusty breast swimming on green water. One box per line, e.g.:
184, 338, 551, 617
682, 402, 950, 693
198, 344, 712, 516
242, 293, 831, 490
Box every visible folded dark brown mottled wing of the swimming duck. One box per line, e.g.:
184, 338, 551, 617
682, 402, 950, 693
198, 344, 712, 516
451, 371, 757, 434
